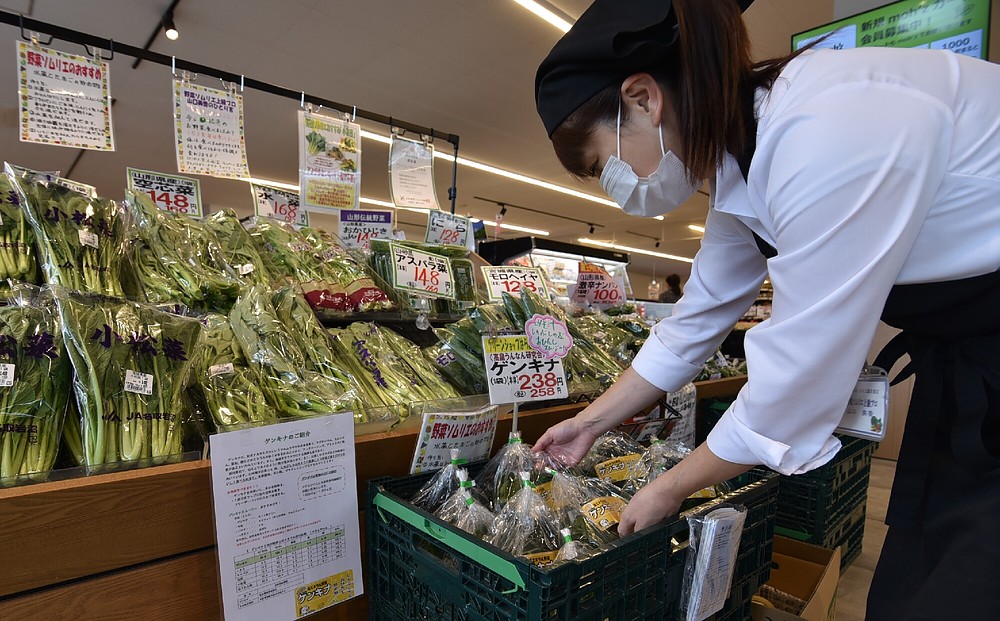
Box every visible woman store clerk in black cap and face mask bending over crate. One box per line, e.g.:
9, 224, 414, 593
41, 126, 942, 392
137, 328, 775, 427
535, 0, 1000, 620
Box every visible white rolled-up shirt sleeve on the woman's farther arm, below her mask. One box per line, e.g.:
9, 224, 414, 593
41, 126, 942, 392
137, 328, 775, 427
632, 209, 767, 392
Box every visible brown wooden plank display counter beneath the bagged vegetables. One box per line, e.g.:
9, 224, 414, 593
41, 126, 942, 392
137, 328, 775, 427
0, 378, 745, 621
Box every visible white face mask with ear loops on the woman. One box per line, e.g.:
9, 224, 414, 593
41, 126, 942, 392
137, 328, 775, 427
601, 94, 701, 217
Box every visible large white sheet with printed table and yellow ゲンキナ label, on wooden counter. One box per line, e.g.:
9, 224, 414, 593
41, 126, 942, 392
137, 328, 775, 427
210, 413, 364, 621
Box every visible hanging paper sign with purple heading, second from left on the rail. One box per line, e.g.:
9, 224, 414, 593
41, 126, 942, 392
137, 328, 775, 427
174, 80, 250, 179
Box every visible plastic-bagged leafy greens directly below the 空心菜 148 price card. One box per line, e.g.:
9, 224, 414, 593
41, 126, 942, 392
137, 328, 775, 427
125, 192, 241, 312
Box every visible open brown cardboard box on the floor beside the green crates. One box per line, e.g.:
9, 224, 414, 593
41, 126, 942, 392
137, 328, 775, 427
751, 536, 840, 621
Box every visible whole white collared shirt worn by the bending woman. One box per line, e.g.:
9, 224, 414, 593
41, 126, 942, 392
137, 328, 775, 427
632, 48, 1000, 474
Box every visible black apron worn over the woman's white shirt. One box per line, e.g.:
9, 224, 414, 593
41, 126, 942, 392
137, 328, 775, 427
737, 93, 1000, 621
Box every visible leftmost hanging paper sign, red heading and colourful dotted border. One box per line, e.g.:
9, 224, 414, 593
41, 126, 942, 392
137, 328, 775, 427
17, 41, 115, 151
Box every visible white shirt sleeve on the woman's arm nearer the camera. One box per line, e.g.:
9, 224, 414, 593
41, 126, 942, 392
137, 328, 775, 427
708, 82, 953, 474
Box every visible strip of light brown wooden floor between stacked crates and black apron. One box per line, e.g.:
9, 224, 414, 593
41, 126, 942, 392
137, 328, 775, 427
837, 459, 896, 621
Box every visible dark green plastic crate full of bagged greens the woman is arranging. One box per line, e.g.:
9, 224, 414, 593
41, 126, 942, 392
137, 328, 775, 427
365, 464, 777, 621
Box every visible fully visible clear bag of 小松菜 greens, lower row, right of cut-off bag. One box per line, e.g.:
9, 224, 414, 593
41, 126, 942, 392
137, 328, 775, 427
53, 287, 202, 469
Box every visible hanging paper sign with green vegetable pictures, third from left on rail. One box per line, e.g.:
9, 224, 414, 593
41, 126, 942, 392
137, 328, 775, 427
299, 110, 361, 212
